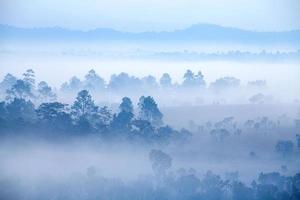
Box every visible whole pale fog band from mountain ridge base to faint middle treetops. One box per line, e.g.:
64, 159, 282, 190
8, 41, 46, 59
0, 41, 300, 94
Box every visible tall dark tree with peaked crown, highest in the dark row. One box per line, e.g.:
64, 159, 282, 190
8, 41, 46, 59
71, 90, 98, 119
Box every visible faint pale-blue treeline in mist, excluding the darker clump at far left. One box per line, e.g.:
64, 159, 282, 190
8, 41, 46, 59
57, 70, 267, 91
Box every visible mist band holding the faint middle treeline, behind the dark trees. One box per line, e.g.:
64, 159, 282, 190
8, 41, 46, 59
0, 68, 300, 106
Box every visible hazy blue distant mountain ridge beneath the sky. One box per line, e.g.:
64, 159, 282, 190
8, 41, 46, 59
0, 24, 300, 45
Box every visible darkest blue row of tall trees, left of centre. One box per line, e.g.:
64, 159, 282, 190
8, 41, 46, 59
0, 87, 190, 141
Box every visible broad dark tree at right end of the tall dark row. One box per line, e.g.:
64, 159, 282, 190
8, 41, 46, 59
138, 96, 163, 127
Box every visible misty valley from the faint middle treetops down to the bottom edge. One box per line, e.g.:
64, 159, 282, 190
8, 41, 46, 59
0, 69, 300, 200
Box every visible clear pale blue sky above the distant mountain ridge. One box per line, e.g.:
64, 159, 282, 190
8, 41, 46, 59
0, 0, 300, 32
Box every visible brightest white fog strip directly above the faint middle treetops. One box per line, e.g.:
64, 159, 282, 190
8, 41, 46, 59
0, 56, 299, 88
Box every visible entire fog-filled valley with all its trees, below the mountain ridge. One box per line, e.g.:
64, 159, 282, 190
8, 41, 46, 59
0, 35, 300, 200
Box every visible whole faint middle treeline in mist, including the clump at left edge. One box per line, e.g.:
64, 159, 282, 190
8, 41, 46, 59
0, 69, 267, 102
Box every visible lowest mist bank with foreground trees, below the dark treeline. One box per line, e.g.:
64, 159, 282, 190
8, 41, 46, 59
0, 139, 299, 200
